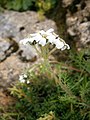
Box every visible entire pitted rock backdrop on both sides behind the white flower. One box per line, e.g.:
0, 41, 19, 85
0, 0, 90, 105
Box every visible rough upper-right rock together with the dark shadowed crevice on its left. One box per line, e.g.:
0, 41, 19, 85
54, 0, 90, 48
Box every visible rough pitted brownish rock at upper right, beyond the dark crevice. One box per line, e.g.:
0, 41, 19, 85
63, 0, 90, 47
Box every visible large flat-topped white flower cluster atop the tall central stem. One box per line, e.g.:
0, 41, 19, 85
20, 28, 70, 50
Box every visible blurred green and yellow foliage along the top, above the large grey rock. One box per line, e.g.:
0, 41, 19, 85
0, 0, 57, 12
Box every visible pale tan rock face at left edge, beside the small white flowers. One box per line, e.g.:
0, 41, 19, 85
0, 54, 31, 91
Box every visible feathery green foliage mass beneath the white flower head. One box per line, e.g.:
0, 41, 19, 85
0, 48, 90, 120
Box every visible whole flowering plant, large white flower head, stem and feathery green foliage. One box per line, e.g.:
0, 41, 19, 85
4, 29, 90, 120
